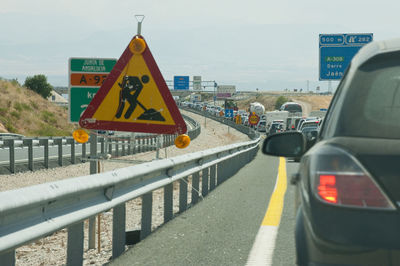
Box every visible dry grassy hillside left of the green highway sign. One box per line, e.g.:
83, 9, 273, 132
0, 80, 75, 136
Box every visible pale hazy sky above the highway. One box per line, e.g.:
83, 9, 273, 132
0, 0, 400, 91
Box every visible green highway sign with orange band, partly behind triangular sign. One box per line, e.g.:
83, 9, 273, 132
68, 58, 117, 123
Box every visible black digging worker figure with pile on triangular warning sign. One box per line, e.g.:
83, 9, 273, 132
115, 75, 165, 121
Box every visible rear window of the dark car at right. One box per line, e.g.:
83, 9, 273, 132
337, 52, 400, 139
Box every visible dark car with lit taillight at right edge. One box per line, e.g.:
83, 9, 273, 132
263, 39, 400, 265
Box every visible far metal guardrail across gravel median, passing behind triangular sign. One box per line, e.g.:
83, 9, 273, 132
0, 115, 201, 173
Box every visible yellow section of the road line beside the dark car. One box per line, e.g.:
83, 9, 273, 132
261, 157, 287, 226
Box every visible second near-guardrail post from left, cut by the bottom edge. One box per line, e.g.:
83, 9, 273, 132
67, 222, 83, 266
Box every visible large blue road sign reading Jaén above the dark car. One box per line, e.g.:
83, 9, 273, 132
319, 33, 373, 80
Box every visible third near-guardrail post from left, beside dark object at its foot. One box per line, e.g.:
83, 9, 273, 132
112, 203, 126, 259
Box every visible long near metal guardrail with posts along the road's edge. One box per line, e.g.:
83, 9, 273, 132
0, 138, 260, 265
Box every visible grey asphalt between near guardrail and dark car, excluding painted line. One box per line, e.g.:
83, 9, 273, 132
111, 149, 298, 265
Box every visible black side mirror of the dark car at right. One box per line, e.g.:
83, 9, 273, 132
262, 132, 307, 157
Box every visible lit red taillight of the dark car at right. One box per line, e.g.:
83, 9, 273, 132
312, 146, 395, 210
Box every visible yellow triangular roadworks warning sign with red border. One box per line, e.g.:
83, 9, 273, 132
79, 35, 186, 134
